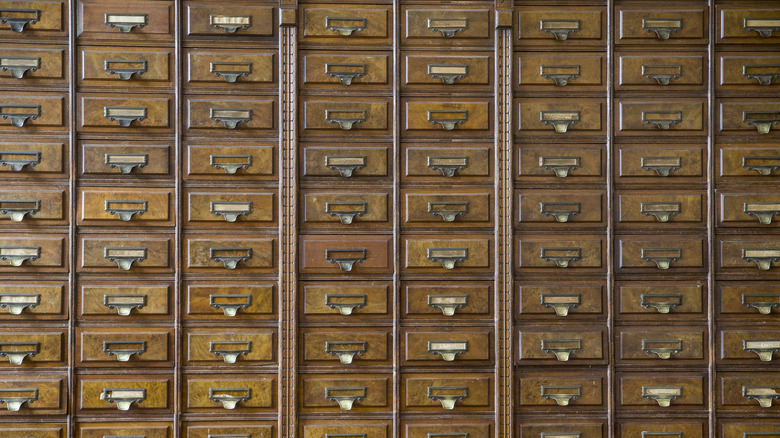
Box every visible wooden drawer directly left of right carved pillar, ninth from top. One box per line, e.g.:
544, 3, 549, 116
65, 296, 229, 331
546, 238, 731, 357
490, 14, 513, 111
401, 373, 494, 413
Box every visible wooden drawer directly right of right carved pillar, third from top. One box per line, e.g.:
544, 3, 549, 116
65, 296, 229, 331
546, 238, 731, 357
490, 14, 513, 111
515, 98, 606, 136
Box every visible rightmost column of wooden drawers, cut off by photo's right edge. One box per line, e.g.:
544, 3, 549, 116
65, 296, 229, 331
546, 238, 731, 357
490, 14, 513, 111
713, 1, 780, 438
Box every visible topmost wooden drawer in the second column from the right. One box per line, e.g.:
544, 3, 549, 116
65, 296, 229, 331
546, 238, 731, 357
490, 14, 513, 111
615, 6, 709, 45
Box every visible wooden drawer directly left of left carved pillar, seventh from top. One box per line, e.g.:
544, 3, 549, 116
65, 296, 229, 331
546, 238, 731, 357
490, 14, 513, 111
184, 281, 276, 321
